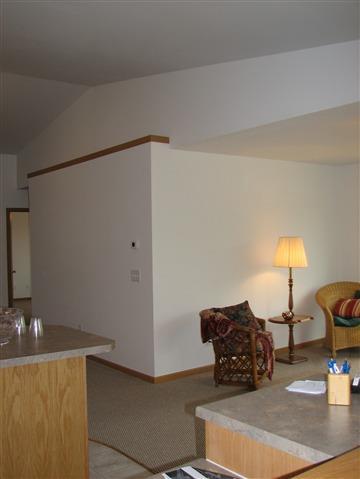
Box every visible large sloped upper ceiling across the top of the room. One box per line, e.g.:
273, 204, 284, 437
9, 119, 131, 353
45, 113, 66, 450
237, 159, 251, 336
0, 0, 359, 156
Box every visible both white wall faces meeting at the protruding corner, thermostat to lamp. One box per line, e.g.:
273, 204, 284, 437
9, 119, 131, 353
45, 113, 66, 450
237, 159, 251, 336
26, 143, 359, 376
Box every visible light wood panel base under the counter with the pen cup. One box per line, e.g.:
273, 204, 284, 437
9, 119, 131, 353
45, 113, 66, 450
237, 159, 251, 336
205, 421, 311, 479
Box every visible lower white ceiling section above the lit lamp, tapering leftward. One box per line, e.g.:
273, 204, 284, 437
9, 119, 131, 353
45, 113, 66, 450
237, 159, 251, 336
188, 103, 360, 165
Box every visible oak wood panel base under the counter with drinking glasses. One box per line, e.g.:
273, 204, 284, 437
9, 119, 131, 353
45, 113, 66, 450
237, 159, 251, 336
0, 357, 88, 479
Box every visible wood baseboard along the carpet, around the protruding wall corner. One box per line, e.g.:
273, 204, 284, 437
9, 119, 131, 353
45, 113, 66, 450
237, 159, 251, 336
88, 338, 325, 384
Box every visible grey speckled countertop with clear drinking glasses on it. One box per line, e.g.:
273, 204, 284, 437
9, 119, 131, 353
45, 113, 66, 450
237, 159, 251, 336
0, 324, 115, 368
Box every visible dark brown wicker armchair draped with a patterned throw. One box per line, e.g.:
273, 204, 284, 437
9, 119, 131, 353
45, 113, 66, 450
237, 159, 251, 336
199, 305, 273, 389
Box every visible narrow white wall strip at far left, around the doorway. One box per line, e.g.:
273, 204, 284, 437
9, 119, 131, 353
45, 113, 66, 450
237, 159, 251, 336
0, 153, 29, 305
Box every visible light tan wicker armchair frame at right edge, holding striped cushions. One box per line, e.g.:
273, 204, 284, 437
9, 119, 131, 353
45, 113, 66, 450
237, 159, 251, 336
315, 281, 360, 358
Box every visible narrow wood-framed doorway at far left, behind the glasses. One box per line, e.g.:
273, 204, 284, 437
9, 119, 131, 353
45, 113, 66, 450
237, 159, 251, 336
6, 208, 31, 318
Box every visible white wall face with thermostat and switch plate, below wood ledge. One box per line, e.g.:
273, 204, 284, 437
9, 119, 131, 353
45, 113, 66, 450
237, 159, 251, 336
30, 144, 154, 375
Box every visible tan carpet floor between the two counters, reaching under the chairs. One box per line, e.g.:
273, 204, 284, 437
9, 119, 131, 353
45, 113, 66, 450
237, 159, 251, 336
87, 348, 360, 472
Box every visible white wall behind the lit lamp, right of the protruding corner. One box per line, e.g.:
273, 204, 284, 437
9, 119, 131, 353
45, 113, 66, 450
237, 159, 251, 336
152, 144, 359, 376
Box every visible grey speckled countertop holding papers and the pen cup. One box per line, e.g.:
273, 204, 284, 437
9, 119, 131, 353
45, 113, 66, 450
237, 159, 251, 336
196, 377, 360, 462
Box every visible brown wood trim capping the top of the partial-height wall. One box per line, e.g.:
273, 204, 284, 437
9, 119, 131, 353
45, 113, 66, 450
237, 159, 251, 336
27, 135, 170, 178
